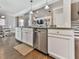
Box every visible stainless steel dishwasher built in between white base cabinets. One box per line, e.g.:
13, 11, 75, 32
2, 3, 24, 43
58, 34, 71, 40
34, 29, 48, 54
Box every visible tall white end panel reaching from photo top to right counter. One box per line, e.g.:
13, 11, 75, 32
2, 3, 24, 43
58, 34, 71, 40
63, 0, 72, 28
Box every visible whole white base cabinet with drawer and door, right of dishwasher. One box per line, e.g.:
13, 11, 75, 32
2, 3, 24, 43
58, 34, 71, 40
48, 29, 75, 59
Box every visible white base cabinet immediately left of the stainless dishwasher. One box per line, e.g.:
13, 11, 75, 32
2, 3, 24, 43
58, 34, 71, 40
22, 28, 33, 46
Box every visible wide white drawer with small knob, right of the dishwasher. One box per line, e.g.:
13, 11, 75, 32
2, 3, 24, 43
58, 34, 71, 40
48, 29, 74, 36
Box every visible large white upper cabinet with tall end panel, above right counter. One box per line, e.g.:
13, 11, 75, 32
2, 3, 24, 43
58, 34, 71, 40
53, 0, 71, 28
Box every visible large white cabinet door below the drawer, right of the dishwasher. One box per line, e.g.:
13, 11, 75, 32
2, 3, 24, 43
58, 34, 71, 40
48, 36, 69, 59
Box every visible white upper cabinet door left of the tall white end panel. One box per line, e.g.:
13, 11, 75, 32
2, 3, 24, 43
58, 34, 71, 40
53, 8, 65, 27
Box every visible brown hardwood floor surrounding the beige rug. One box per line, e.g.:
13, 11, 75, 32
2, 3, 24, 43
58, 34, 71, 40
0, 36, 53, 59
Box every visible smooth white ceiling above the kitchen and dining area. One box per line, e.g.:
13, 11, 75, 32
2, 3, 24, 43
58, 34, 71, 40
0, 0, 57, 15
